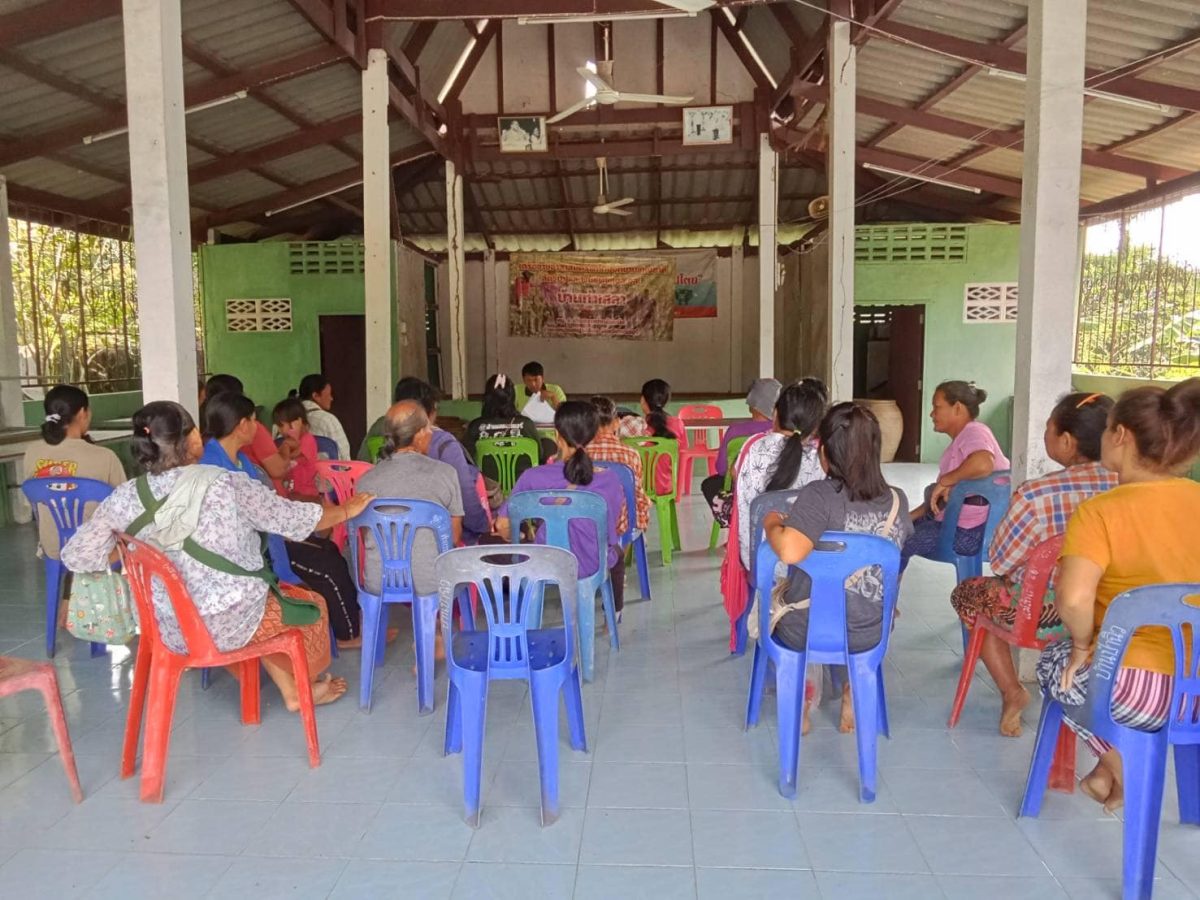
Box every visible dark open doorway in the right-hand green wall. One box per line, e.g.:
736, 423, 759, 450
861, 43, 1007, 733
854, 304, 925, 462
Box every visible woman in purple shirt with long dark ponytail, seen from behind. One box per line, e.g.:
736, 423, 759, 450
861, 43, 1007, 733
496, 400, 628, 622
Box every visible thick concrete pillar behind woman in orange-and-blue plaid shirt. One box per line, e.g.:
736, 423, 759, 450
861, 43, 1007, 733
1013, 0, 1087, 482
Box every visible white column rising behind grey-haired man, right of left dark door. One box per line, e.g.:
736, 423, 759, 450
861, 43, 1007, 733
362, 49, 392, 416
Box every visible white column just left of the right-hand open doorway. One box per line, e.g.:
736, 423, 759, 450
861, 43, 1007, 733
826, 19, 857, 402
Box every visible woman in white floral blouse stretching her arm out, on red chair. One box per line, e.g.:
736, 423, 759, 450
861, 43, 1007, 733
62, 401, 373, 712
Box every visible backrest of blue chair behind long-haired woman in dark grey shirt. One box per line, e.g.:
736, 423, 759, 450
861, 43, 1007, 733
755, 532, 900, 661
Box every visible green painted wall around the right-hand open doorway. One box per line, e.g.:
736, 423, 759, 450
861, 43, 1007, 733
854, 224, 1020, 462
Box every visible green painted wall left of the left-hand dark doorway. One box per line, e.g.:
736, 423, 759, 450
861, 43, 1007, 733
200, 241, 398, 415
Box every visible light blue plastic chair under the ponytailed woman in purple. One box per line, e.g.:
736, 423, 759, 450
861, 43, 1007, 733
509, 491, 620, 682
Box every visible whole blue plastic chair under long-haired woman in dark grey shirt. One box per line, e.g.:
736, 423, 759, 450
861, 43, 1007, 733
746, 532, 900, 803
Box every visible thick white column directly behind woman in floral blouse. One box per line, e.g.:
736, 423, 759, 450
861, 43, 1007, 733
122, 0, 198, 415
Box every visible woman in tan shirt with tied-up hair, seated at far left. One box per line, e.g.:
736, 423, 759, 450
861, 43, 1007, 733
22, 384, 125, 564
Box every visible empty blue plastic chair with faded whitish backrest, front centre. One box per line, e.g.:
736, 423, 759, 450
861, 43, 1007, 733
436, 544, 587, 827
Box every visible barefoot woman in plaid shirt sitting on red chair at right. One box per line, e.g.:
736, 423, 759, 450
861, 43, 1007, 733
950, 392, 1117, 738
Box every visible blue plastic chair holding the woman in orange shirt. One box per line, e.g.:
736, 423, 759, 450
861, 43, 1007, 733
1021, 582, 1200, 899
